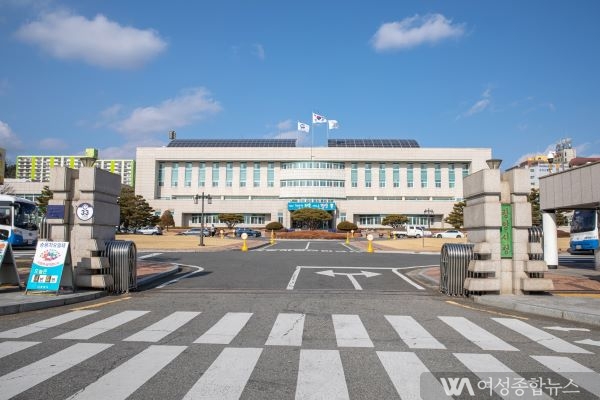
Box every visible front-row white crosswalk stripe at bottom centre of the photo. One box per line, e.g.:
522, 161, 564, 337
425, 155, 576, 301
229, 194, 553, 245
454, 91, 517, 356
296, 350, 350, 400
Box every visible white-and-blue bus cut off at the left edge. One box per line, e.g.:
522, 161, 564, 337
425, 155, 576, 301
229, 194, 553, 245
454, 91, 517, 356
0, 194, 38, 247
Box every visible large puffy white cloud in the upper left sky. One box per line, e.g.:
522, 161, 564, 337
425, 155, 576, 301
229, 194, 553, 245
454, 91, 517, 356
16, 11, 167, 69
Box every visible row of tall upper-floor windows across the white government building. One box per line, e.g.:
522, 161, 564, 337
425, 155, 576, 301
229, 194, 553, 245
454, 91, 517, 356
157, 161, 469, 188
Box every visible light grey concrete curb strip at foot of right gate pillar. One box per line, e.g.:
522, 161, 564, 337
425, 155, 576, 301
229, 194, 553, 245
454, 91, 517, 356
472, 295, 600, 326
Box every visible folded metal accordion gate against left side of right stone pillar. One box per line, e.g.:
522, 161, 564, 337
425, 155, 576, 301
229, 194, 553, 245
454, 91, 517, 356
440, 243, 474, 296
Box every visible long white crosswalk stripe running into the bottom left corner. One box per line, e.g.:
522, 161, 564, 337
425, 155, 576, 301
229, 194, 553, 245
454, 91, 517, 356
0, 343, 112, 400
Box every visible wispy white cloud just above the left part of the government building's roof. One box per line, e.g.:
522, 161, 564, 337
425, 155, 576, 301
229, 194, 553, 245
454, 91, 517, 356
116, 88, 222, 134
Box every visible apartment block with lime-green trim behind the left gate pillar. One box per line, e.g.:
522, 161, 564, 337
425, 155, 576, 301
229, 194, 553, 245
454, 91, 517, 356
16, 149, 135, 187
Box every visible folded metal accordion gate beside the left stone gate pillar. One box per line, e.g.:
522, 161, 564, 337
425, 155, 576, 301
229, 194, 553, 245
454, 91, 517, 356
102, 240, 137, 293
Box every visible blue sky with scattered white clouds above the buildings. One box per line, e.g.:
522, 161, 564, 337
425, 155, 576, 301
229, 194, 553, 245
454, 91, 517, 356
0, 0, 600, 168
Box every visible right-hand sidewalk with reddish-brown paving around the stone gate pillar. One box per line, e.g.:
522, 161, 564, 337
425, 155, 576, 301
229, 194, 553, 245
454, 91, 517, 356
417, 265, 600, 326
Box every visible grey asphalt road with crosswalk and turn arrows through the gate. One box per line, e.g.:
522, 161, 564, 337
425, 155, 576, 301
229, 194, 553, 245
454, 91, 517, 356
5, 241, 600, 400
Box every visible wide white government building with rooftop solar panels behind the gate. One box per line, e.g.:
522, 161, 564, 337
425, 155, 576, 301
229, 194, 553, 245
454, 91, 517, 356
135, 139, 492, 229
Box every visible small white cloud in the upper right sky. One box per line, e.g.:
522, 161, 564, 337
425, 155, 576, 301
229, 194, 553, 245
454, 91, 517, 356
371, 14, 465, 51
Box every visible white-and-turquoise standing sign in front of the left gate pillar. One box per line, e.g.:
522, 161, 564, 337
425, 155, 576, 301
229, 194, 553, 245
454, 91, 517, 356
26, 242, 71, 292
